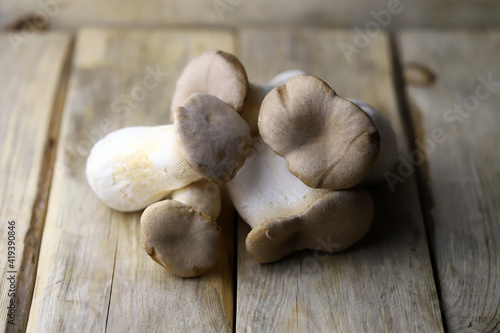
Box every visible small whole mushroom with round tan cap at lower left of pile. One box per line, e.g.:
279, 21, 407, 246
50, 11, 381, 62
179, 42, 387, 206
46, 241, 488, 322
141, 180, 221, 277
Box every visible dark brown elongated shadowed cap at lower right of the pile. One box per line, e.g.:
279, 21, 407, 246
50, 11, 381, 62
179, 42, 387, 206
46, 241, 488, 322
245, 189, 373, 263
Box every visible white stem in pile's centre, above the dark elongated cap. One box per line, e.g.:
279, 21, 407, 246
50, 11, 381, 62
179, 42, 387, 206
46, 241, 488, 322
227, 138, 330, 228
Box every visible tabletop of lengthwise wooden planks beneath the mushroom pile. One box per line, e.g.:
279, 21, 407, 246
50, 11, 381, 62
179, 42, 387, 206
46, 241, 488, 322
0, 28, 500, 332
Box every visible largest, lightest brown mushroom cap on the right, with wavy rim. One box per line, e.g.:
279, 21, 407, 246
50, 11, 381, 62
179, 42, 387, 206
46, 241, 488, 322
258, 75, 380, 190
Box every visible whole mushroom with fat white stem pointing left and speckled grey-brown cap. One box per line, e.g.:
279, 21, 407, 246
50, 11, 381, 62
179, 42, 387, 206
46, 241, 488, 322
87, 93, 251, 211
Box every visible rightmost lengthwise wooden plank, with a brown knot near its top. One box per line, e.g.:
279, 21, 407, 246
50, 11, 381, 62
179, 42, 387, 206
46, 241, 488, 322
398, 31, 500, 332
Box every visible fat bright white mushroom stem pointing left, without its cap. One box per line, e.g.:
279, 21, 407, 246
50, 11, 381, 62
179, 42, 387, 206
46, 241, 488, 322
86, 125, 202, 212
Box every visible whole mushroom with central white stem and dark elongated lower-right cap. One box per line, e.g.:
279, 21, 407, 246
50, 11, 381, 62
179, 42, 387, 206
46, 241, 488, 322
227, 138, 373, 263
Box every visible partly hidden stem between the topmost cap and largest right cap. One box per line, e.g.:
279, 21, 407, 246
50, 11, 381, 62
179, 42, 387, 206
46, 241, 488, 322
241, 69, 306, 135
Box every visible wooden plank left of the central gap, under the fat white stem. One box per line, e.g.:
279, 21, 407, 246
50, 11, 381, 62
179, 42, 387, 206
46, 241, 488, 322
28, 29, 234, 332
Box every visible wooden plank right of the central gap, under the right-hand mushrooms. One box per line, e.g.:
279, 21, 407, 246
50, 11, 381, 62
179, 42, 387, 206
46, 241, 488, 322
236, 29, 443, 332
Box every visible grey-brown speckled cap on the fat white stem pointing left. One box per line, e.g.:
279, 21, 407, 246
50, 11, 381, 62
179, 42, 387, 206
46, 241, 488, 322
174, 93, 252, 185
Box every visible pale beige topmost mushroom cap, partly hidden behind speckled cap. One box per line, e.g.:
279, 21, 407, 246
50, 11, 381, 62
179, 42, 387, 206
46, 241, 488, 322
171, 50, 248, 117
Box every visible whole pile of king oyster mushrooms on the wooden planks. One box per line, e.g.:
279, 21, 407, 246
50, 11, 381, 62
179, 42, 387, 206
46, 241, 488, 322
86, 51, 396, 277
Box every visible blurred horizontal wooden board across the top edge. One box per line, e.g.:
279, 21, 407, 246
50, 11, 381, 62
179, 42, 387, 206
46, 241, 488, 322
0, 0, 500, 31
